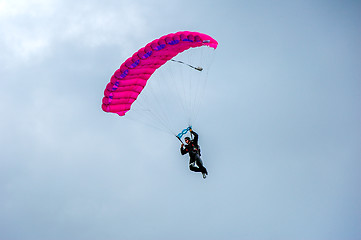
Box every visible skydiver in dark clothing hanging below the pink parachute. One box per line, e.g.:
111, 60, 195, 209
180, 129, 208, 178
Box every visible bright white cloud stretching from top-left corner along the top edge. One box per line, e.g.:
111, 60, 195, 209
0, 0, 146, 66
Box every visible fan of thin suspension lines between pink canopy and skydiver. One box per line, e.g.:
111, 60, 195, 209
127, 47, 214, 139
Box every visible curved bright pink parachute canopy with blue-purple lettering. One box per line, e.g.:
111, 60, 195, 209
102, 31, 218, 116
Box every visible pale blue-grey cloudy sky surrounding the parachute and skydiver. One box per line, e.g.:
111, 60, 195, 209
0, 0, 361, 240
